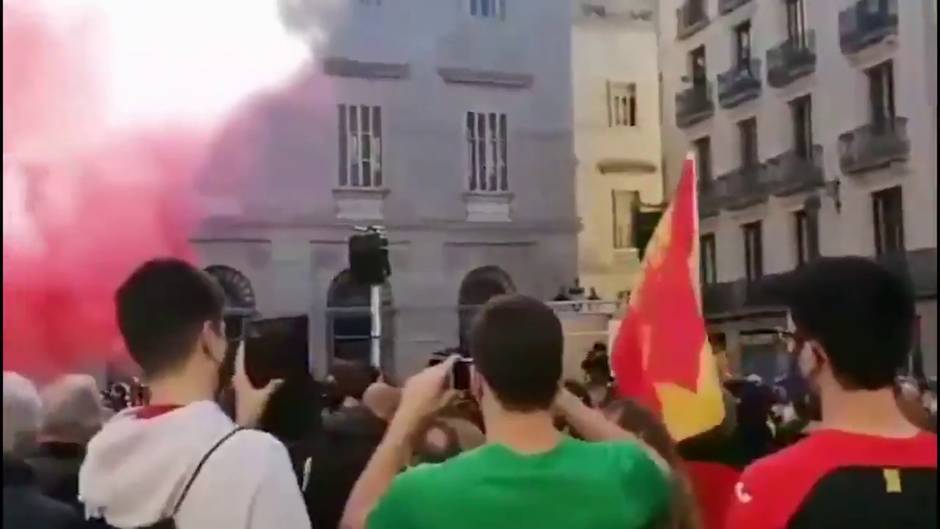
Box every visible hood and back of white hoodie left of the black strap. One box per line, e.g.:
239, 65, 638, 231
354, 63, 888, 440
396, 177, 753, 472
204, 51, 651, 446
79, 401, 235, 527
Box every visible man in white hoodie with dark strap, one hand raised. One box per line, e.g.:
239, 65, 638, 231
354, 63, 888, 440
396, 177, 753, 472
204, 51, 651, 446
79, 259, 310, 529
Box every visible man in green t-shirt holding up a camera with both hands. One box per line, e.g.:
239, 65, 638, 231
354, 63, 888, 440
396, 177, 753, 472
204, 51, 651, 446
341, 295, 671, 529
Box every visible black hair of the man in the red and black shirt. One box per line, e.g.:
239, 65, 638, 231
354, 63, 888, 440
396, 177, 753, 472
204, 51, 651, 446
781, 257, 915, 390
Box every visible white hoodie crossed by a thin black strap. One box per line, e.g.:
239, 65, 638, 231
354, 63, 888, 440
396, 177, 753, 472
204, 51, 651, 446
78, 401, 310, 529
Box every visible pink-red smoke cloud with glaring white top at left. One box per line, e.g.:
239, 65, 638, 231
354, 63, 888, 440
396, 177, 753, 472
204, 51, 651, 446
3, 0, 306, 376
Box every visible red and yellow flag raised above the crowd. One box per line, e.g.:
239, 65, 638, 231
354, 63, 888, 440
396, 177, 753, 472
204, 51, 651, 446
611, 155, 724, 441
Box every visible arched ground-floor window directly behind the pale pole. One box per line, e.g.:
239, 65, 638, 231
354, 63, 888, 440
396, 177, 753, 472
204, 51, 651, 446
327, 270, 395, 369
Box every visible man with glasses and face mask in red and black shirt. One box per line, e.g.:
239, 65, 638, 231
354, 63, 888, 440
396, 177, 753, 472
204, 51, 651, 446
726, 257, 937, 529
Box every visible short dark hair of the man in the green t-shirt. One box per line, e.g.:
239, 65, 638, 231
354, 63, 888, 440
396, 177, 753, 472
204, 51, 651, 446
470, 294, 563, 413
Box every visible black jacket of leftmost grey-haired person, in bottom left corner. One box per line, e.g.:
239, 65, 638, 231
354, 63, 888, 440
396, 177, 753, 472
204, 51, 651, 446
3, 455, 85, 529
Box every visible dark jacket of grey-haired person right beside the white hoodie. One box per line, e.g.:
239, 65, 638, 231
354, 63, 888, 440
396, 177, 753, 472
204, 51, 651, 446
26, 442, 85, 508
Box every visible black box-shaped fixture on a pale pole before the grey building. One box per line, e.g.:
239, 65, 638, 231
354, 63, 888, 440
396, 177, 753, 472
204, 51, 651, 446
349, 226, 392, 369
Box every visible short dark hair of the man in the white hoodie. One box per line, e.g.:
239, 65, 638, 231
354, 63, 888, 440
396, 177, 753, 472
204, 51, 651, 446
115, 259, 225, 377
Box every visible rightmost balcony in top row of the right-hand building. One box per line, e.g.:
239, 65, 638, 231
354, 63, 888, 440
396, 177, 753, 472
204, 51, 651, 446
839, 0, 898, 55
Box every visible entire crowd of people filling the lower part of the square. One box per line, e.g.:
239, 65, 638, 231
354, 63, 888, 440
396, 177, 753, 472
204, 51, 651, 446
3, 258, 937, 529
